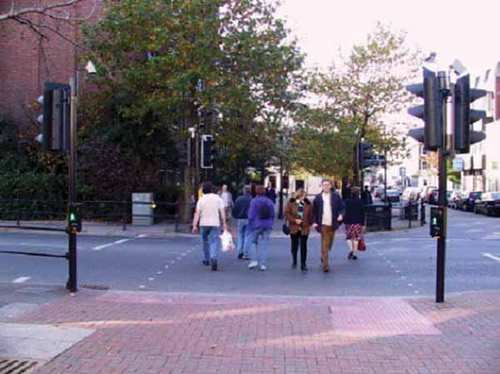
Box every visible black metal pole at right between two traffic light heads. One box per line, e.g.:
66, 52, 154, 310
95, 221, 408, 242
436, 72, 449, 303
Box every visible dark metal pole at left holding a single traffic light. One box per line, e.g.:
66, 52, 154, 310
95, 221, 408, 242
66, 78, 78, 292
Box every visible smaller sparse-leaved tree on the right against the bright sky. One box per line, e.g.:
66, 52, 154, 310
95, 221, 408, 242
295, 24, 417, 182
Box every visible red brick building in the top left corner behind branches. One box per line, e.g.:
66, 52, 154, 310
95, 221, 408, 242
0, 0, 103, 134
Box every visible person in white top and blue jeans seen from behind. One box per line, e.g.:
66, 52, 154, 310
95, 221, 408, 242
193, 182, 228, 271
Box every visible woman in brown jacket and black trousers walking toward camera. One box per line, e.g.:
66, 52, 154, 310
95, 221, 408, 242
285, 188, 313, 272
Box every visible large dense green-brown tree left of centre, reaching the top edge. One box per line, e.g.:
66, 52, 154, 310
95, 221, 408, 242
82, 0, 303, 206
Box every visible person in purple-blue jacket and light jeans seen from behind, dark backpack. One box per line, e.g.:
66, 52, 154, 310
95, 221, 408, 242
248, 186, 274, 271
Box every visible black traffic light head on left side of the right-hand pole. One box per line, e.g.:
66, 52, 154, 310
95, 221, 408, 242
406, 67, 443, 151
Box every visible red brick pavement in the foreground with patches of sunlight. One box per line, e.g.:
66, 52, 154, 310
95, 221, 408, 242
10, 290, 500, 374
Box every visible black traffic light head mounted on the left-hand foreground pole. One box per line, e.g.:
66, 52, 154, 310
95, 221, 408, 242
36, 82, 70, 152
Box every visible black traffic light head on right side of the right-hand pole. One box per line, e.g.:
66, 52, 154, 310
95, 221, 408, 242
453, 74, 487, 153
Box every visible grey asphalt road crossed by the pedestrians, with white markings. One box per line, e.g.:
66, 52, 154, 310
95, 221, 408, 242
0, 210, 500, 296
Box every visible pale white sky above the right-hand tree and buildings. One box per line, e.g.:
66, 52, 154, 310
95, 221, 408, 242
278, 0, 500, 75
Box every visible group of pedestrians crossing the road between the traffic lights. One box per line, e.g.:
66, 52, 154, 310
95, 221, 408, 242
193, 179, 365, 273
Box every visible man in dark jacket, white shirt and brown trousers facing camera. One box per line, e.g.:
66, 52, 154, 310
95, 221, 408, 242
313, 179, 345, 273
